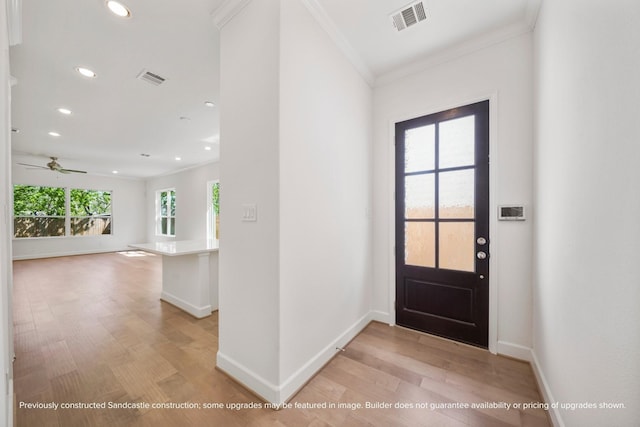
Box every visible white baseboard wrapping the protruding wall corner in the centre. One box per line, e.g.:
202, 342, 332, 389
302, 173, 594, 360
216, 313, 373, 405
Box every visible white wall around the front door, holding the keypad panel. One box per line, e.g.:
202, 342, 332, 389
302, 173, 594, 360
373, 34, 535, 358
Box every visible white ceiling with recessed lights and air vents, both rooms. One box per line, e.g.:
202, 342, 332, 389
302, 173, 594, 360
10, 0, 539, 178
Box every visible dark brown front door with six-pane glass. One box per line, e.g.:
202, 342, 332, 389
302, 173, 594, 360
396, 101, 489, 347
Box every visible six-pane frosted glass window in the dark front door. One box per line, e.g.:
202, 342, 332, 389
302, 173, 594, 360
404, 115, 475, 272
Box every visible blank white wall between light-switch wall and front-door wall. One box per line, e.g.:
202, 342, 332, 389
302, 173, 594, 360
280, 1, 372, 392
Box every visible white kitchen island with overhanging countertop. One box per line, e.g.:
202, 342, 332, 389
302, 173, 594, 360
129, 240, 218, 319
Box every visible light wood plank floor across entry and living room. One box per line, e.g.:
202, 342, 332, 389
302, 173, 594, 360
14, 253, 549, 427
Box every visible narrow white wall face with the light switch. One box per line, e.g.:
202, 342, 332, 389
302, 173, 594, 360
217, 1, 280, 400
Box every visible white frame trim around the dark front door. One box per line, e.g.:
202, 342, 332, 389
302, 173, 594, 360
387, 92, 499, 354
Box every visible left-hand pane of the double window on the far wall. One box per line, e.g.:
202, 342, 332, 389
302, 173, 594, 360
13, 185, 66, 238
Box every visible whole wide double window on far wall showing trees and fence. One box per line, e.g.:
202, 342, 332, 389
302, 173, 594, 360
13, 185, 111, 238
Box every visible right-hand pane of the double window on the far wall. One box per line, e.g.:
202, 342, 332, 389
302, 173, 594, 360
69, 188, 111, 236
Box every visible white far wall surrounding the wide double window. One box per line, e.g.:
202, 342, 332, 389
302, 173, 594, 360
12, 166, 146, 259
